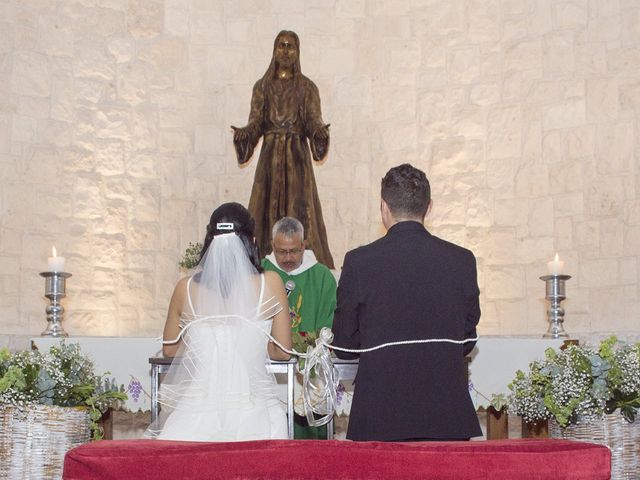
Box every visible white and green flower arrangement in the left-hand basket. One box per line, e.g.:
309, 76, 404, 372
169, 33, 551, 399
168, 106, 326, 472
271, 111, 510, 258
0, 342, 127, 439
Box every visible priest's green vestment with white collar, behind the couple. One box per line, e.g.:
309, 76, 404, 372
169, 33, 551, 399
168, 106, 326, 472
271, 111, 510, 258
262, 250, 337, 439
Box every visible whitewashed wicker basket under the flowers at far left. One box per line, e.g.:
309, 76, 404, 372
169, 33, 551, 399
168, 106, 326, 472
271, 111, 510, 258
0, 405, 91, 480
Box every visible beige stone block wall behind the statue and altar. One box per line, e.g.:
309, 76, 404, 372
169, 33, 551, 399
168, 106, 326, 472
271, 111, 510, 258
0, 0, 640, 336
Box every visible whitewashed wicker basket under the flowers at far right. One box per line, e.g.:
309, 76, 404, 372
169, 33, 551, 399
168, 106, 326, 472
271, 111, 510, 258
549, 412, 640, 480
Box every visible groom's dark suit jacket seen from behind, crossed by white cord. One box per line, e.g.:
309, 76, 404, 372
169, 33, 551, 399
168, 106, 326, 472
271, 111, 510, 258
333, 221, 482, 440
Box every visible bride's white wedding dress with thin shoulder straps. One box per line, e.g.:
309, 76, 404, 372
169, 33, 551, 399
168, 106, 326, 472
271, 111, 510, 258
145, 234, 287, 442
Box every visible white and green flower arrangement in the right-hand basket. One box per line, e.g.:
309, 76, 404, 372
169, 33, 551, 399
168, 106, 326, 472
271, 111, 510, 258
508, 337, 640, 427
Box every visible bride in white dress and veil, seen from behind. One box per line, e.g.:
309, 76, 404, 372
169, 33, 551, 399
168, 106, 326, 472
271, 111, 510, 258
145, 203, 291, 441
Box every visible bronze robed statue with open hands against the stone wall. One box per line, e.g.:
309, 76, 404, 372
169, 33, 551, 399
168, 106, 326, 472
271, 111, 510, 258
231, 31, 334, 268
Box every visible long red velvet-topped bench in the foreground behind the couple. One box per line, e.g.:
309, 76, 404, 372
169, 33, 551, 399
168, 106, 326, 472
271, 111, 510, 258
63, 439, 611, 480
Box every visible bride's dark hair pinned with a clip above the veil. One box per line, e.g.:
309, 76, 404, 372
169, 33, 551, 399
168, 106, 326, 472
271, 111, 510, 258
200, 202, 264, 273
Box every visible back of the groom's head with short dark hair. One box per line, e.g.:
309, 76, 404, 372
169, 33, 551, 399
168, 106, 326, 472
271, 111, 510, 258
381, 163, 431, 218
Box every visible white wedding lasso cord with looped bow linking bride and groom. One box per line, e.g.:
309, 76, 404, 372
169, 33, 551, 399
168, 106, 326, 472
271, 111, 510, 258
162, 300, 479, 427
